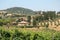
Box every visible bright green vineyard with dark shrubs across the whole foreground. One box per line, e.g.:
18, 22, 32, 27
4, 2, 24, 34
0, 27, 60, 40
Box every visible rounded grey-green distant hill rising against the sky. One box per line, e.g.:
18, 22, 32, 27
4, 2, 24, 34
5, 7, 35, 15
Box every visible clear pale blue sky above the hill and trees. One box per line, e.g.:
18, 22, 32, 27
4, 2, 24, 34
0, 0, 60, 11
